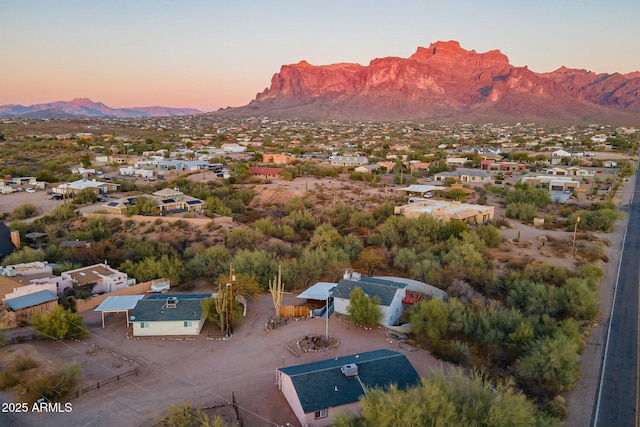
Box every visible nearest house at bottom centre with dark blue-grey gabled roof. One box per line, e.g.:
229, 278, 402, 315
276, 349, 420, 427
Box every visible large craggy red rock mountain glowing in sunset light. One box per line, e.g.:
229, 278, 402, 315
230, 41, 640, 125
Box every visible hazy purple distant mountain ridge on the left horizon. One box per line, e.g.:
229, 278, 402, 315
0, 98, 202, 119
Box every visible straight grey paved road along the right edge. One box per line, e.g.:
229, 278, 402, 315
593, 169, 640, 427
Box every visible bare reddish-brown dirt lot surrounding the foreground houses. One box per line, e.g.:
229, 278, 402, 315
0, 295, 444, 427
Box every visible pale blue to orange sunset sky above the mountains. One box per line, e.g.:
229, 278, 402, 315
0, 0, 640, 112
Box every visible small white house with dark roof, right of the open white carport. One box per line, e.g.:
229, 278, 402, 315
130, 294, 209, 337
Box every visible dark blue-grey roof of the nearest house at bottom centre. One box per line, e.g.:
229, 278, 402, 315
279, 349, 420, 413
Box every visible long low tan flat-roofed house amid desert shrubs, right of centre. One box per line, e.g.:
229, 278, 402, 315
393, 200, 495, 224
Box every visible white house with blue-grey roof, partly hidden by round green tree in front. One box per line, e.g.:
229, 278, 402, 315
331, 272, 407, 326
